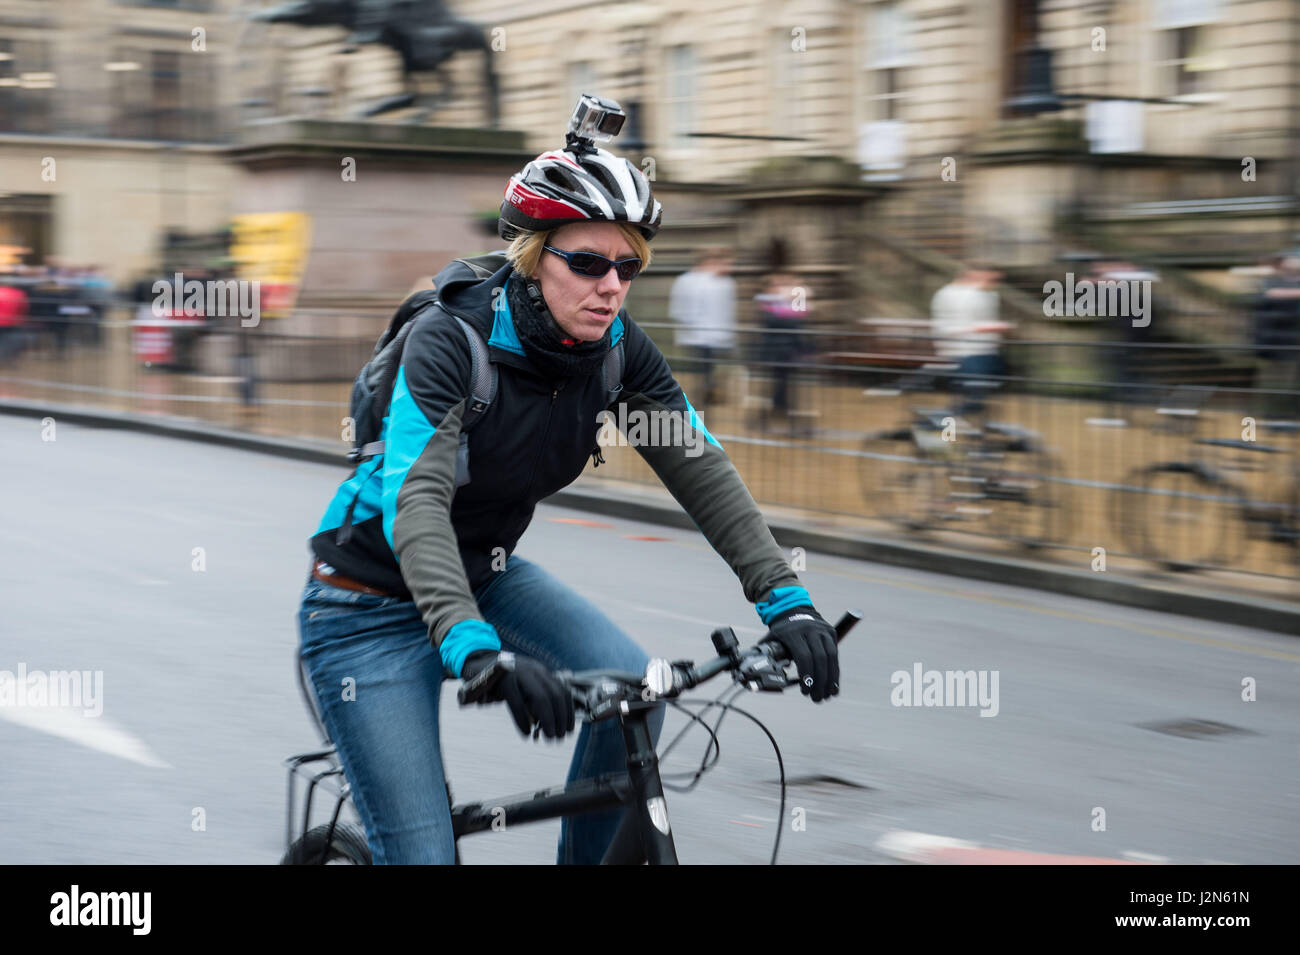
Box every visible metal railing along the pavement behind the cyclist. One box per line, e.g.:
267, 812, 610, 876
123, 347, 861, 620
0, 316, 1300, 596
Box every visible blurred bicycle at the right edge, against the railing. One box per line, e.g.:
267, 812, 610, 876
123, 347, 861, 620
1115, 399, 1300, 572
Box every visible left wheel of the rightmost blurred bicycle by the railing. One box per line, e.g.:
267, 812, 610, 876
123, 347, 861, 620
1119, 461, 1245, 570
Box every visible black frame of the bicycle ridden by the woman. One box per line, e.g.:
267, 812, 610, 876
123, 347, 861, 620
451, 702, 677, 865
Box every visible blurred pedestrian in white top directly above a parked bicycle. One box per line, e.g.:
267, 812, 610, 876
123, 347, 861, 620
930, 262, 1013, 412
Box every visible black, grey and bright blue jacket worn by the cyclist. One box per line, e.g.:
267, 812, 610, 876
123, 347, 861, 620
311, 261, 810, 676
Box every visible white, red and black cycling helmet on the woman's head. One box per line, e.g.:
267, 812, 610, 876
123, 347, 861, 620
497, 148, 663, 239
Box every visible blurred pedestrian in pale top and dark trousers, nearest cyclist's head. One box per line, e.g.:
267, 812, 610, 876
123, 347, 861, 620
668, 246, 736, 407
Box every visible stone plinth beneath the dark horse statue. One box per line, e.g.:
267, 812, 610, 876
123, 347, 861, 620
204, 118, 533, 381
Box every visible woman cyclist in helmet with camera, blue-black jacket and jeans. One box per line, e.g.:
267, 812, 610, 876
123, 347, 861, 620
299, 97, 839, 864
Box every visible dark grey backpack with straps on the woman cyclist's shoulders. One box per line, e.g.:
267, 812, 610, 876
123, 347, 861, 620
335, 252, 624, 544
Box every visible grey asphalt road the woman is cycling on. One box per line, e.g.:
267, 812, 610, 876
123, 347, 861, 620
0, 416, 1300, 864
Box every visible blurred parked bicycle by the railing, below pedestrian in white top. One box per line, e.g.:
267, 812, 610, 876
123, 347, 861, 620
858, 373, 1069, 550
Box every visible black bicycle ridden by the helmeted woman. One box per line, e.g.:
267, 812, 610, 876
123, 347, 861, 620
281, 611, 862, 865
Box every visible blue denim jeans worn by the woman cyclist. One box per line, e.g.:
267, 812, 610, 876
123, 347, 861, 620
298, 556, 664, 865
